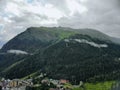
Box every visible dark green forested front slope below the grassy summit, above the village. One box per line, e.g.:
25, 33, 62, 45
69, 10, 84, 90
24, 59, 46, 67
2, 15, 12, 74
2, 34, 120, 82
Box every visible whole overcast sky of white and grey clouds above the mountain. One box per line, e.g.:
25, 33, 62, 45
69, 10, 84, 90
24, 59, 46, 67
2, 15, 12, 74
0, 0, 120, 47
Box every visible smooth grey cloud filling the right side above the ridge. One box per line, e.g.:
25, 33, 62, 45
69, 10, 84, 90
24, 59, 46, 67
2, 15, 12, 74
59, 0, 120, 37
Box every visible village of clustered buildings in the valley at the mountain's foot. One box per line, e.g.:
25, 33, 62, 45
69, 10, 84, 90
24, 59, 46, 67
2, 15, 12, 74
0, 75, 83, 90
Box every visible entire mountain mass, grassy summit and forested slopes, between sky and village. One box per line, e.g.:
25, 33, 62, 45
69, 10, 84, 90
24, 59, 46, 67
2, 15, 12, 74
0, 27, 120, 82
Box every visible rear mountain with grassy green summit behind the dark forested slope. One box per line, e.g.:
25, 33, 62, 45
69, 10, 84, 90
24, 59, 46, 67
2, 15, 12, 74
1, 27, 120, 53
